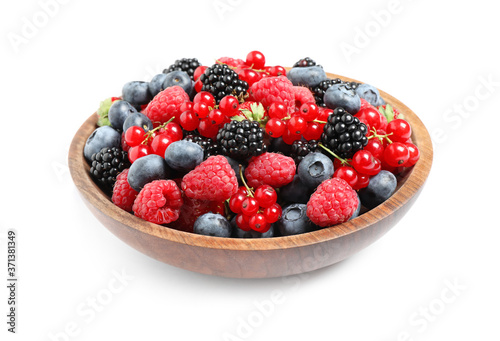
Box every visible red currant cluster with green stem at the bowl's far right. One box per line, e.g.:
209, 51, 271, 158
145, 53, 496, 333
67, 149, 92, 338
321, 107, 420, 190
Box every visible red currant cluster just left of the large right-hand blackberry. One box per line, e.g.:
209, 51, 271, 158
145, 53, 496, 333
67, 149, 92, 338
266, 103, 333, 144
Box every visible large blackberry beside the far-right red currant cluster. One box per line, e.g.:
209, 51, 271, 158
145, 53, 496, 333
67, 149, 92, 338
321, 107, 368, 159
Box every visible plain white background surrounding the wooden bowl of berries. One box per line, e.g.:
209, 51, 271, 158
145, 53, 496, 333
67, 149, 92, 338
0, 0, 500, 341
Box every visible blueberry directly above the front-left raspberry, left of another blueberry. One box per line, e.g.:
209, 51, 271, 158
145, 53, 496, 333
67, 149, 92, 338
127, 154, 170, 192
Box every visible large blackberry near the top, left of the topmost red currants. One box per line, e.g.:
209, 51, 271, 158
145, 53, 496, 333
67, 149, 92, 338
200, 64, 248, 103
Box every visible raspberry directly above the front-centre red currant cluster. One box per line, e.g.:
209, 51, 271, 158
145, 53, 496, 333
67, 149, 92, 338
245, 153, 296, 188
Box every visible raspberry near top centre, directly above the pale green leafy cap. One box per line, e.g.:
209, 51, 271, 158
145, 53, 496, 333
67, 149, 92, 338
249, 76, 295, 113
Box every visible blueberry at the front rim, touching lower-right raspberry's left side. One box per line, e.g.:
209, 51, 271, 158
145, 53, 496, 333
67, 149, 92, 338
277, 204, 314, 236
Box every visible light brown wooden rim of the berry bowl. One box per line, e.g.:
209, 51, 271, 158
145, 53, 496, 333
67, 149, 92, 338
68, 73, 433, 251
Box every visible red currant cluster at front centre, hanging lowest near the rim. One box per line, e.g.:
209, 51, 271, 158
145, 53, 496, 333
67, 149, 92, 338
229, 185, 281, 233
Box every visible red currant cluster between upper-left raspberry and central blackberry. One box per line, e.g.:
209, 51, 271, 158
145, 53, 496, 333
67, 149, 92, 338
179, 91, 239, 138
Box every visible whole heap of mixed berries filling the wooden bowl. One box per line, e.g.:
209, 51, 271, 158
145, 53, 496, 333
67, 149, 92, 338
83, 51, 420, 238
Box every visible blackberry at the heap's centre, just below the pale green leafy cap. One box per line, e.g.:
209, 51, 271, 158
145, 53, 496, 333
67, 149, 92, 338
217, 120, 267, 160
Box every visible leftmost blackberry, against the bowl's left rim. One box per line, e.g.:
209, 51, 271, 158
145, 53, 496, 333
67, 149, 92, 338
90, 147, 130, 188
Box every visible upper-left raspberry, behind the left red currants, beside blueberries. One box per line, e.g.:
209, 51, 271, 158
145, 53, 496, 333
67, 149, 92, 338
145, 85, 189, 126
